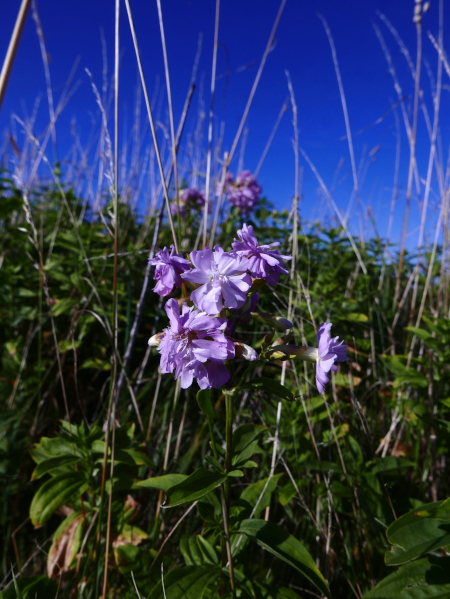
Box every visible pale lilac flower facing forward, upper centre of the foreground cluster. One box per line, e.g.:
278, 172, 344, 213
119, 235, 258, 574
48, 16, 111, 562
182, 245, 252, 314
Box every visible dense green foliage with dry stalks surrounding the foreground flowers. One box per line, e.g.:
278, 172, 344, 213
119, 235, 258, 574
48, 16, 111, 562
0, 169, 450, 599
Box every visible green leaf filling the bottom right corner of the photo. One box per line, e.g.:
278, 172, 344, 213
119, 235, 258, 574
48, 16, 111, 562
363, 556, 450, 599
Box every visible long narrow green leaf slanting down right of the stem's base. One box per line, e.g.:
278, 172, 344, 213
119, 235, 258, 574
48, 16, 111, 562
237, 520, 331, 597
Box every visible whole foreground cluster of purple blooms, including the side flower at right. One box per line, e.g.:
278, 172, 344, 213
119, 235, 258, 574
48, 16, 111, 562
149, 224, 348, 393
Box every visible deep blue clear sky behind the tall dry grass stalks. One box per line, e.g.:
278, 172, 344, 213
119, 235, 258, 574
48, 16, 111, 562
0, 0, 450, 246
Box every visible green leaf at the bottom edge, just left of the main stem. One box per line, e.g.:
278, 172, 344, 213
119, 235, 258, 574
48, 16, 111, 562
149, 565, 222, 599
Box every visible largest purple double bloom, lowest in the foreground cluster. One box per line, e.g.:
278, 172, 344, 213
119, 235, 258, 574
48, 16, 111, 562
149, 298, 235, 389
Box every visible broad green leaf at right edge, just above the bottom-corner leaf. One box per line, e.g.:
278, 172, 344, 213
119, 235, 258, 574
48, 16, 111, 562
386, 501, 450, 566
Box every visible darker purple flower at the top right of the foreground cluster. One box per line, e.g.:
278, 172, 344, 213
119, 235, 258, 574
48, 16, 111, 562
232, 224, 292, 285
